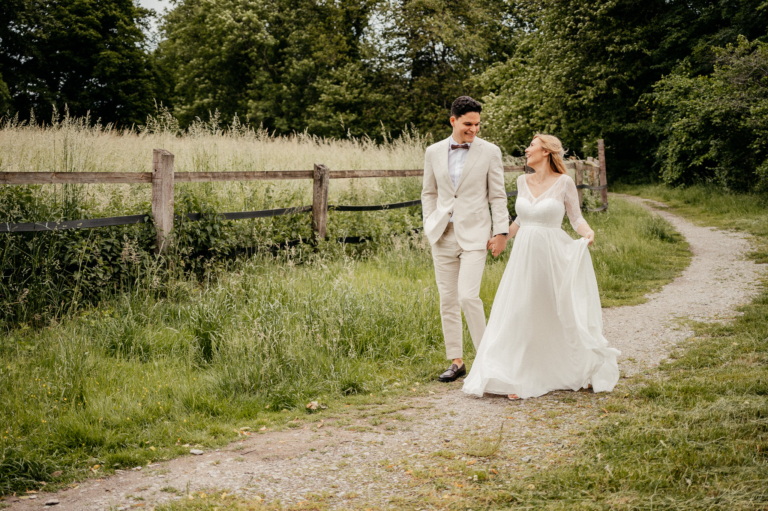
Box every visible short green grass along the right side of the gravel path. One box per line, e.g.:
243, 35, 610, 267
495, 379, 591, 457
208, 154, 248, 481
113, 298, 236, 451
147, 186, 768, 511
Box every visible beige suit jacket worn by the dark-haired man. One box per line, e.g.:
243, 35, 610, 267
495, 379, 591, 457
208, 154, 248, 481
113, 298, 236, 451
421, 138, 509, 250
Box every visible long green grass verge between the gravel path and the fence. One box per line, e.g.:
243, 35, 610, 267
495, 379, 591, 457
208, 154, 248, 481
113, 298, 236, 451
0, 196, 689, 493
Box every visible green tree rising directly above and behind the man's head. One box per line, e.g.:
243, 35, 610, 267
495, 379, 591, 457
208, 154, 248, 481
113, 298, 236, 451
374, 0, 520, 136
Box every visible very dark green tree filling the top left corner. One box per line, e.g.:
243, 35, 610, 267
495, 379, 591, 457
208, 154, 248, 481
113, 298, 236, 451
0, 0, 155, 125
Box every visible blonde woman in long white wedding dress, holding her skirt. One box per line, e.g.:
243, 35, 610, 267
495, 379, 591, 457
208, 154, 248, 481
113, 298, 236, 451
462, 135, 620, 399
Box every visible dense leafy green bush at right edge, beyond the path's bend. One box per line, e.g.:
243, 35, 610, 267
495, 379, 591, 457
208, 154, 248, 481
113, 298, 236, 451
652, 37, 768, 191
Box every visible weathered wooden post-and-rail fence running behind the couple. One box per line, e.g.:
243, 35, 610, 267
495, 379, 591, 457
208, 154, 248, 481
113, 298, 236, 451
0, 140, 608, 252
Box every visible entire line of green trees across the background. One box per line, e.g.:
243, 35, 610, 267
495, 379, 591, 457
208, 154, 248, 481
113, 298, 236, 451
0, 0, 768, 191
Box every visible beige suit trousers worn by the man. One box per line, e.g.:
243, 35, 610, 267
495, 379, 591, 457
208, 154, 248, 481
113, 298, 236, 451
432, 224, 488, 360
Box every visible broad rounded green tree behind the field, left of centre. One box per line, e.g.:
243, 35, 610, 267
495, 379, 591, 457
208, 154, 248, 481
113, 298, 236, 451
157, 0, 380, 134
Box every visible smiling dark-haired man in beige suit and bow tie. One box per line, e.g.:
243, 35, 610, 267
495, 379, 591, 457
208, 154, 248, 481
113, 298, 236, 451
421, 96, 509, 382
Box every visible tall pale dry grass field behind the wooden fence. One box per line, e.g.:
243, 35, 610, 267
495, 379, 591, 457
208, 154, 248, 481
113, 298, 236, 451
0, 111, 432, 214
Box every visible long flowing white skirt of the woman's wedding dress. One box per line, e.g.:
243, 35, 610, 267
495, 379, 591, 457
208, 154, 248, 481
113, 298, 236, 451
462, 226, 621, 398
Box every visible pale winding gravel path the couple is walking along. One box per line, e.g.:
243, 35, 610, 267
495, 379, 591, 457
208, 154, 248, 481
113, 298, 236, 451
4, 197, 761, 510
